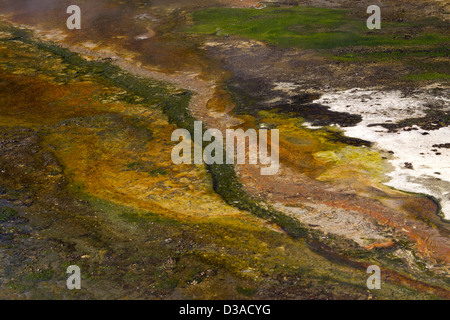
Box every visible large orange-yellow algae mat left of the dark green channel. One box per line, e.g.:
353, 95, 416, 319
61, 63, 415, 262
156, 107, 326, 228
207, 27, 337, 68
0, 30, 266, 222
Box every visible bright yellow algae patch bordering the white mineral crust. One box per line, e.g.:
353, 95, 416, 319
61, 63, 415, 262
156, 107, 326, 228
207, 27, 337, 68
246, 111, 389, 185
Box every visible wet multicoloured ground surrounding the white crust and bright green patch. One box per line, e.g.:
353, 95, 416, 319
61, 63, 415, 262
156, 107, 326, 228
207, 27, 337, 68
0, 1, 450, 299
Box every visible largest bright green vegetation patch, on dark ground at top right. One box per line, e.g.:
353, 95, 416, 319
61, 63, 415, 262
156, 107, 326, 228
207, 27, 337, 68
187, 7, 450, 49
